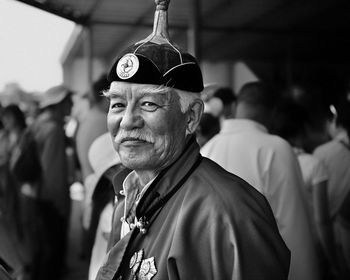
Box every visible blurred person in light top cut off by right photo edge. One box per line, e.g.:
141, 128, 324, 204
314, 99, 350, 279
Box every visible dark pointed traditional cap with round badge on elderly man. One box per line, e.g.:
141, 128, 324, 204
108, 0, 203, 92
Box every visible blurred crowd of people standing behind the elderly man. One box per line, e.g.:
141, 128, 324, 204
0, 75, 350, 280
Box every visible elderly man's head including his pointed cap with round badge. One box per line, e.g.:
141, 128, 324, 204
106, 0, 203, 172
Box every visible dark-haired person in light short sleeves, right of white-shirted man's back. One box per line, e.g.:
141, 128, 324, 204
270, 97, 338, 279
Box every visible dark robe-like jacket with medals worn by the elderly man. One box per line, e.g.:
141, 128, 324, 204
96, 141, 290, 280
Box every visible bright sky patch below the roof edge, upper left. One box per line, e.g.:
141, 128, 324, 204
0, 0, 75, 91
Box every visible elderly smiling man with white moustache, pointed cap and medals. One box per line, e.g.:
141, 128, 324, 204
97, 3, 290, 280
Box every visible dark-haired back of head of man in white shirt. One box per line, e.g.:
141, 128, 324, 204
235, 82, 278, 126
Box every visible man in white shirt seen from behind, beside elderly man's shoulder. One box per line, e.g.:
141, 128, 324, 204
201, 82, 320, 280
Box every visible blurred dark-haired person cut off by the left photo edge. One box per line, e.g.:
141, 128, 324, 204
0, 104, 28, 279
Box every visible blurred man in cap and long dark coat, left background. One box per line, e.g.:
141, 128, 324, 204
32, 86, 72, 280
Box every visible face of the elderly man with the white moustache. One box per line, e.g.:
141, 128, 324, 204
107, 82, 186, 172
